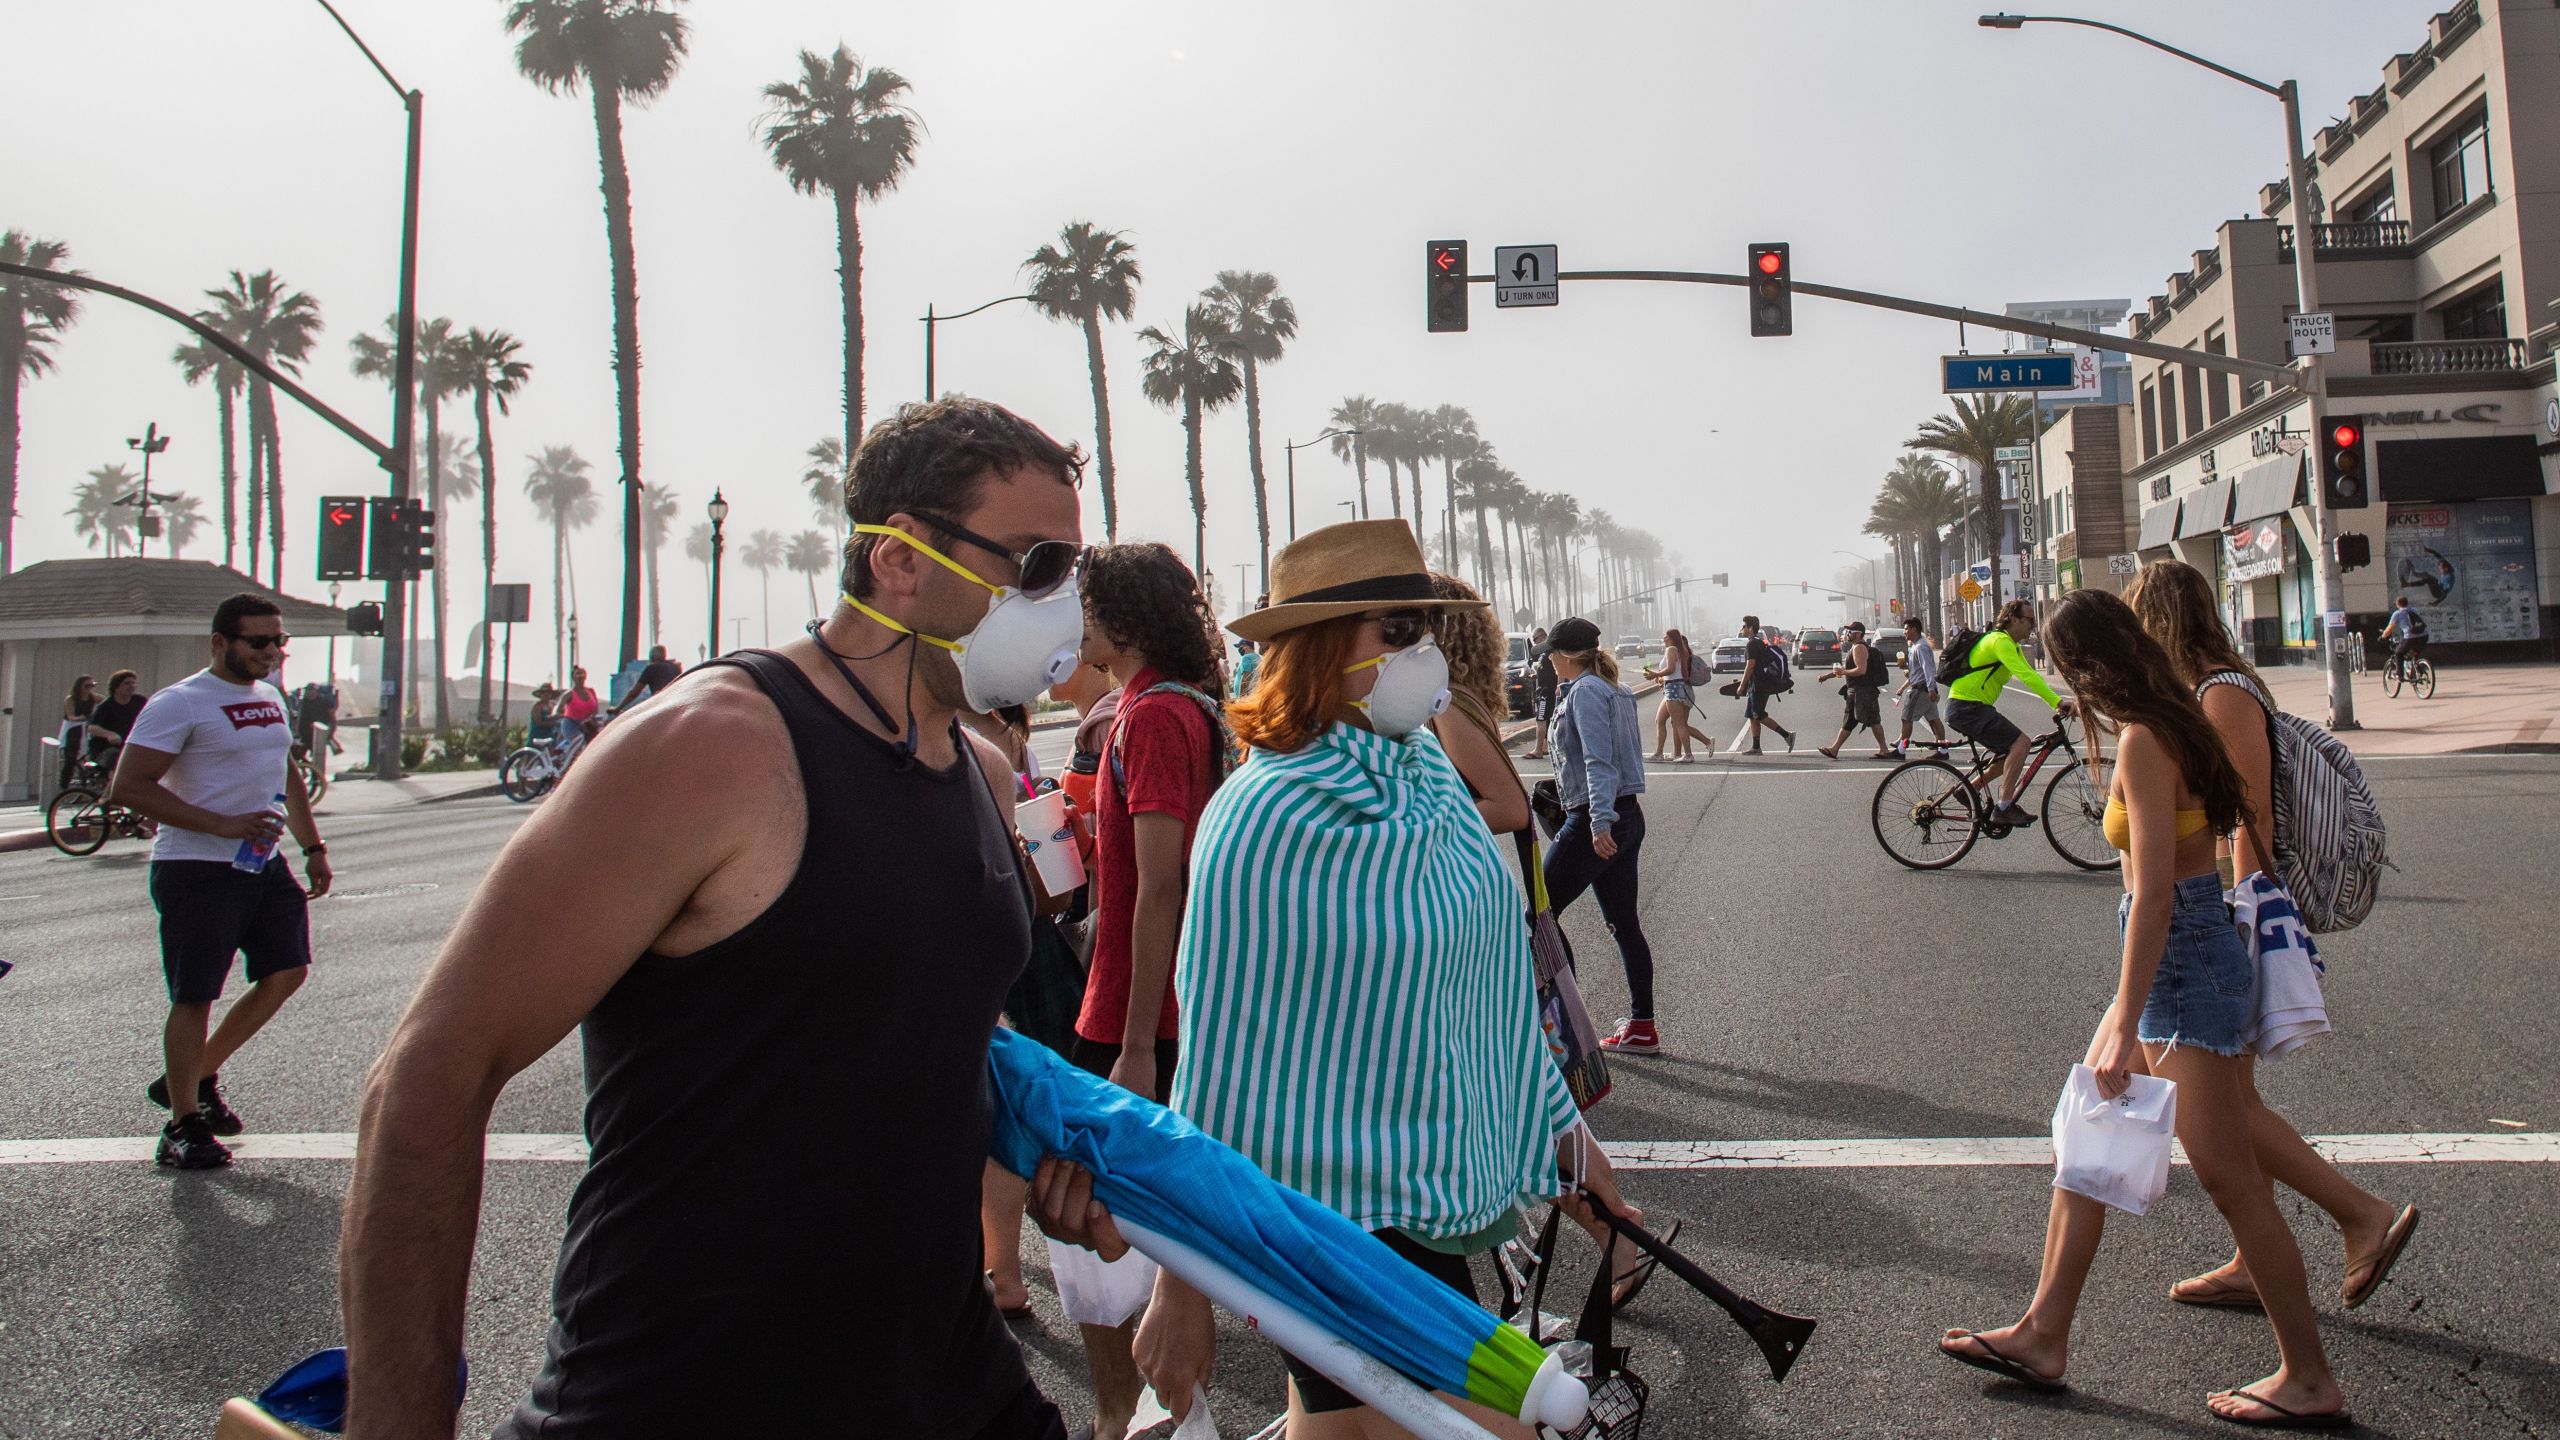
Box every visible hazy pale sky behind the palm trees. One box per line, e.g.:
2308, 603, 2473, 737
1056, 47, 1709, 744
0, 0, 2437, 674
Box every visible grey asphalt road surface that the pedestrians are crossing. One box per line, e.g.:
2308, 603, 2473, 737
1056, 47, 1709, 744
0, 684, 2560, 1440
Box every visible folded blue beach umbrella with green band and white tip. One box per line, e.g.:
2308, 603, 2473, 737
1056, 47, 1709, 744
988, 1030, 1582, 1425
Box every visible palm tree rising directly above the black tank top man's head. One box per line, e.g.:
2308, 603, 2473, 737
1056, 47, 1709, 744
765, 46, 924, 456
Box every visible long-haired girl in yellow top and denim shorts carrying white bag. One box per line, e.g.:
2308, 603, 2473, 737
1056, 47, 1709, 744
1938, 589, 2348, 1430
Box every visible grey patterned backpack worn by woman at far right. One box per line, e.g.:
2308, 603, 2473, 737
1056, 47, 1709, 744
2196, 671, 2391, 935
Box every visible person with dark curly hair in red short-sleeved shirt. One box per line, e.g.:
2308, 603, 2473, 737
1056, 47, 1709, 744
1060, 543, 1226, 1440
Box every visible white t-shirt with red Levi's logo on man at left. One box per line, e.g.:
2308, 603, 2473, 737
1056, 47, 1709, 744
125, 669, 294, 861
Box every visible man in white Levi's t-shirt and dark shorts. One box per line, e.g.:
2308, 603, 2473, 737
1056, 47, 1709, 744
115, 594, 333, 1171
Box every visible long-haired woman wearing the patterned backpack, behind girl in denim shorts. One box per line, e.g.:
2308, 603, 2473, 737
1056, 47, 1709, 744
2125, 561, 2419, 1309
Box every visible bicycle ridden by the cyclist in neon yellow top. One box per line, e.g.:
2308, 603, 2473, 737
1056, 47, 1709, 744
1871, 717, 2125, 871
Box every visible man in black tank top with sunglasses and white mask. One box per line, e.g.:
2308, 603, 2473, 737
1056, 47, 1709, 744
340, 400, 1121, 1440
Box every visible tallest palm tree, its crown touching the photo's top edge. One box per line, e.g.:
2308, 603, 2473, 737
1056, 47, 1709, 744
507, 0, 691, 664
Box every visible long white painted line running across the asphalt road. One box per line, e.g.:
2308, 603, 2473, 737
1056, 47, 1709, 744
0, 1130, 2560, 1171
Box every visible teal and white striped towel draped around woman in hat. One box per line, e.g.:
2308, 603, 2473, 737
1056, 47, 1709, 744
1172, 725, 1574, 1240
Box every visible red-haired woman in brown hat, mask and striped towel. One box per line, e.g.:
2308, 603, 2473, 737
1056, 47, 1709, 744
1137, 520, 1636, 1440
